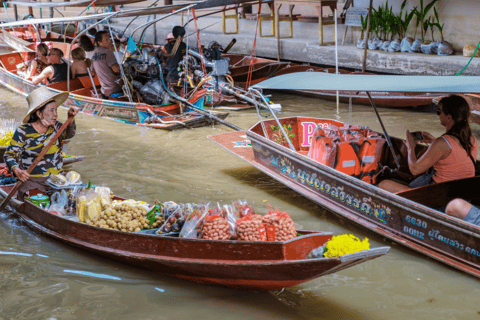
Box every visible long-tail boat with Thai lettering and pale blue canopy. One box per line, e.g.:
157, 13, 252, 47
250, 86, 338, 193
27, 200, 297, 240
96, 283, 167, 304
209, 72, 480, 277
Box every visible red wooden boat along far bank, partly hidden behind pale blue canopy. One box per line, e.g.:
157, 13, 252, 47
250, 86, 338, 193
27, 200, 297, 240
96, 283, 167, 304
225, 54, 440, 108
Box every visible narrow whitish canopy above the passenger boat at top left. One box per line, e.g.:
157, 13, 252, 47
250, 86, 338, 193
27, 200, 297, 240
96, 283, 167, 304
0, 2, 197, 28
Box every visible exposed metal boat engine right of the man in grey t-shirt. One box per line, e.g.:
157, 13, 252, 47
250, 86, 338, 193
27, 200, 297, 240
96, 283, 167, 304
123, 48, 170, 105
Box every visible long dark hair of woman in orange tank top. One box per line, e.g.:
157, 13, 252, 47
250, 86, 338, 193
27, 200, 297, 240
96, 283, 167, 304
438, 95, 473, 155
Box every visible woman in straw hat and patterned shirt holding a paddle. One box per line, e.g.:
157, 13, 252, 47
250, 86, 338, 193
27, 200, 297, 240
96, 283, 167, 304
4, 86, 78, 201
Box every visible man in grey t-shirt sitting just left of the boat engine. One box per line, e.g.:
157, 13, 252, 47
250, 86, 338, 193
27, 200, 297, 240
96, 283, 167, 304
92, 31, 123, 99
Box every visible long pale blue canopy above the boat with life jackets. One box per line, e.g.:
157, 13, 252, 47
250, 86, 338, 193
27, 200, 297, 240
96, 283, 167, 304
254, 72, 480, 93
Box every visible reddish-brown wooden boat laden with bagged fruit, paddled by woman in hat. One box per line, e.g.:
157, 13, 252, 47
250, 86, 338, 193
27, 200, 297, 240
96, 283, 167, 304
0, 190, 390, 291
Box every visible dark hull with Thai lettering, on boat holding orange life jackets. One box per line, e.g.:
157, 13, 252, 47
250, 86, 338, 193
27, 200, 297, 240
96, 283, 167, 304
209, 117, 480, 277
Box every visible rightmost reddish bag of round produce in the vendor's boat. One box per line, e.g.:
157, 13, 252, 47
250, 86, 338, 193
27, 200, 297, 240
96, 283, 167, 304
262, 204, 297, 241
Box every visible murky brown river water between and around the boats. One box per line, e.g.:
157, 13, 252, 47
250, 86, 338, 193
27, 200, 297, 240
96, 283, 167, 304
0, 88, 480, 320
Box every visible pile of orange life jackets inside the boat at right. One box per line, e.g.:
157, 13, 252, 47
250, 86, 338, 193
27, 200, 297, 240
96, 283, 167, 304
308, 124, 385, 184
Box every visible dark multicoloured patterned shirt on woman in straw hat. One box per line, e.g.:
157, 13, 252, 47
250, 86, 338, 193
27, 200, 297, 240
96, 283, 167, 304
3, 121, 76, 177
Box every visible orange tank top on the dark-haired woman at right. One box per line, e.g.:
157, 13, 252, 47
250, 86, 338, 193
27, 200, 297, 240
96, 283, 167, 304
432, 135, 478, 183
